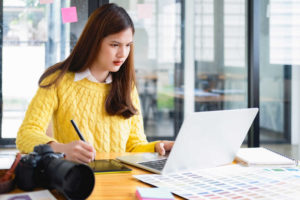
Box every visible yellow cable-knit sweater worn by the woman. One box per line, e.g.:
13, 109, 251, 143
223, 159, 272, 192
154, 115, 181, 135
16, 72, 156, 153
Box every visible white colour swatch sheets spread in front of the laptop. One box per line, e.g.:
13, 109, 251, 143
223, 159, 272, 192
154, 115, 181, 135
134, 165, 300, 200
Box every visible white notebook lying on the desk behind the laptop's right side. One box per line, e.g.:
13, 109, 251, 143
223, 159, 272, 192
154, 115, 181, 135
236, 147, 296, 166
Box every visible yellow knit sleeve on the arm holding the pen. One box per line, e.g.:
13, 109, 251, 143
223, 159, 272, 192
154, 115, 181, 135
16, 73, 58, 153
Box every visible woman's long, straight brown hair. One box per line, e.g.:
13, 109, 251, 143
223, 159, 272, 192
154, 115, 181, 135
39, 3, 137, 118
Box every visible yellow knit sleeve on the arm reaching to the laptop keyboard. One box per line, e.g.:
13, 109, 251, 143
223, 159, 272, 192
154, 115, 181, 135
126, 87, 157, 152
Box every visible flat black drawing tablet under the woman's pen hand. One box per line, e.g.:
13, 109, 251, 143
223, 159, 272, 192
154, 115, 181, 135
88, 159, 132, 174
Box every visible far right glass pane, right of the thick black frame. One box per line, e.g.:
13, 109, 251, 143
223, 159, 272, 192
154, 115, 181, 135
260, 0, 300, 158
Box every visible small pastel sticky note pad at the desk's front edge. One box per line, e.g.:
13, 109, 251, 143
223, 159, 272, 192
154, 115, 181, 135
136, 187, 174, 200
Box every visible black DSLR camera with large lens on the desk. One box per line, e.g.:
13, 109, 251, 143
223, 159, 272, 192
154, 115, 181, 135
15, 144, 95, 200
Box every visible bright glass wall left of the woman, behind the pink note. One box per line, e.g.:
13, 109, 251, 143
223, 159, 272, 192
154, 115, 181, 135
1, 0, 88, 138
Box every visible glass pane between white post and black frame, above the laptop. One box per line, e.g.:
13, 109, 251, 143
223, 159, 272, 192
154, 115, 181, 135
194, 0, 248, 114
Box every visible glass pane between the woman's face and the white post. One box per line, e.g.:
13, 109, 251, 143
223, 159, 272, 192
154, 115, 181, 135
110, 0, 183, 139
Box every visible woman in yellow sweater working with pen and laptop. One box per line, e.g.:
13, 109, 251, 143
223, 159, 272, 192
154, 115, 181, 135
16, 4, 173, 163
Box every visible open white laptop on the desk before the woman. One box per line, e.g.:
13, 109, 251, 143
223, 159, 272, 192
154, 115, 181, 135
117, 108, 258, 174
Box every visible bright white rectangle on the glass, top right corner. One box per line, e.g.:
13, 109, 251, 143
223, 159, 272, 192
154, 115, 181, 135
270, 0, 300, 65
